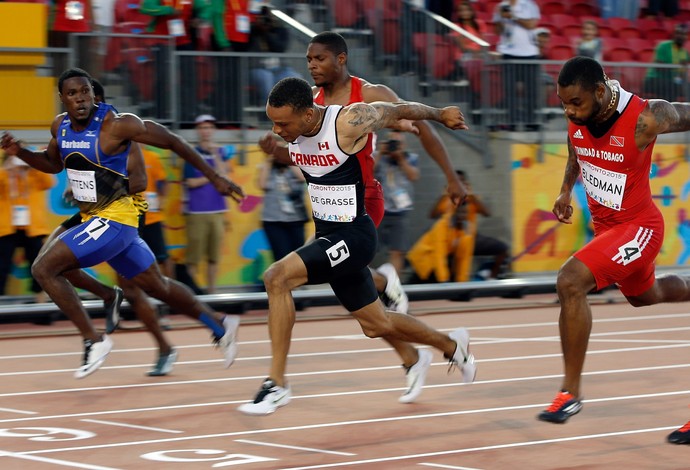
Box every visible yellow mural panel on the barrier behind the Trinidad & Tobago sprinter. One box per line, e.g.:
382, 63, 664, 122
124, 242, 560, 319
512, 144, 690, 272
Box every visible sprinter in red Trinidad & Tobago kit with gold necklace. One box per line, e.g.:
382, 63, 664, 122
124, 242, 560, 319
538, 57, 690, 444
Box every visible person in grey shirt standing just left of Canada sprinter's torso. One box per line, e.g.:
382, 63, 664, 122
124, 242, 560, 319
258, 155, 309, 261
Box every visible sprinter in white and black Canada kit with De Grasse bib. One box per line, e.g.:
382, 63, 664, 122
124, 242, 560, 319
239, 78, 475, 415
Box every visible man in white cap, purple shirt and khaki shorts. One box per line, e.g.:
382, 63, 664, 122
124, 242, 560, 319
183, 114, 230, 294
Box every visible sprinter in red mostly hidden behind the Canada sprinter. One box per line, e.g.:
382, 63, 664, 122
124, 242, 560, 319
260, 31, 467, 313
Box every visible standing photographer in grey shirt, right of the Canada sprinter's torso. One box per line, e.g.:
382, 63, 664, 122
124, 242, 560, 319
374, 132, 419, 275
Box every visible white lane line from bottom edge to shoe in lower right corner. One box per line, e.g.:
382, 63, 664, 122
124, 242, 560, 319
283, 427, 675, 470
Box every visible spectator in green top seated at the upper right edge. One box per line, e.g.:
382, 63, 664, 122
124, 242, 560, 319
644, 24, 689, 102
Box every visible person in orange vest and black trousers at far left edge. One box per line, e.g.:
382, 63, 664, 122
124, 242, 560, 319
0, 145, 55, 302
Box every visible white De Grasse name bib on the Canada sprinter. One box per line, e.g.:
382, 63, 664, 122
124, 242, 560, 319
307, 183, 357, 222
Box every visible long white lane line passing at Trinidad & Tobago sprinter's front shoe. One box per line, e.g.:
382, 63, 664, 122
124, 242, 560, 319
9, 390, 690, 457
